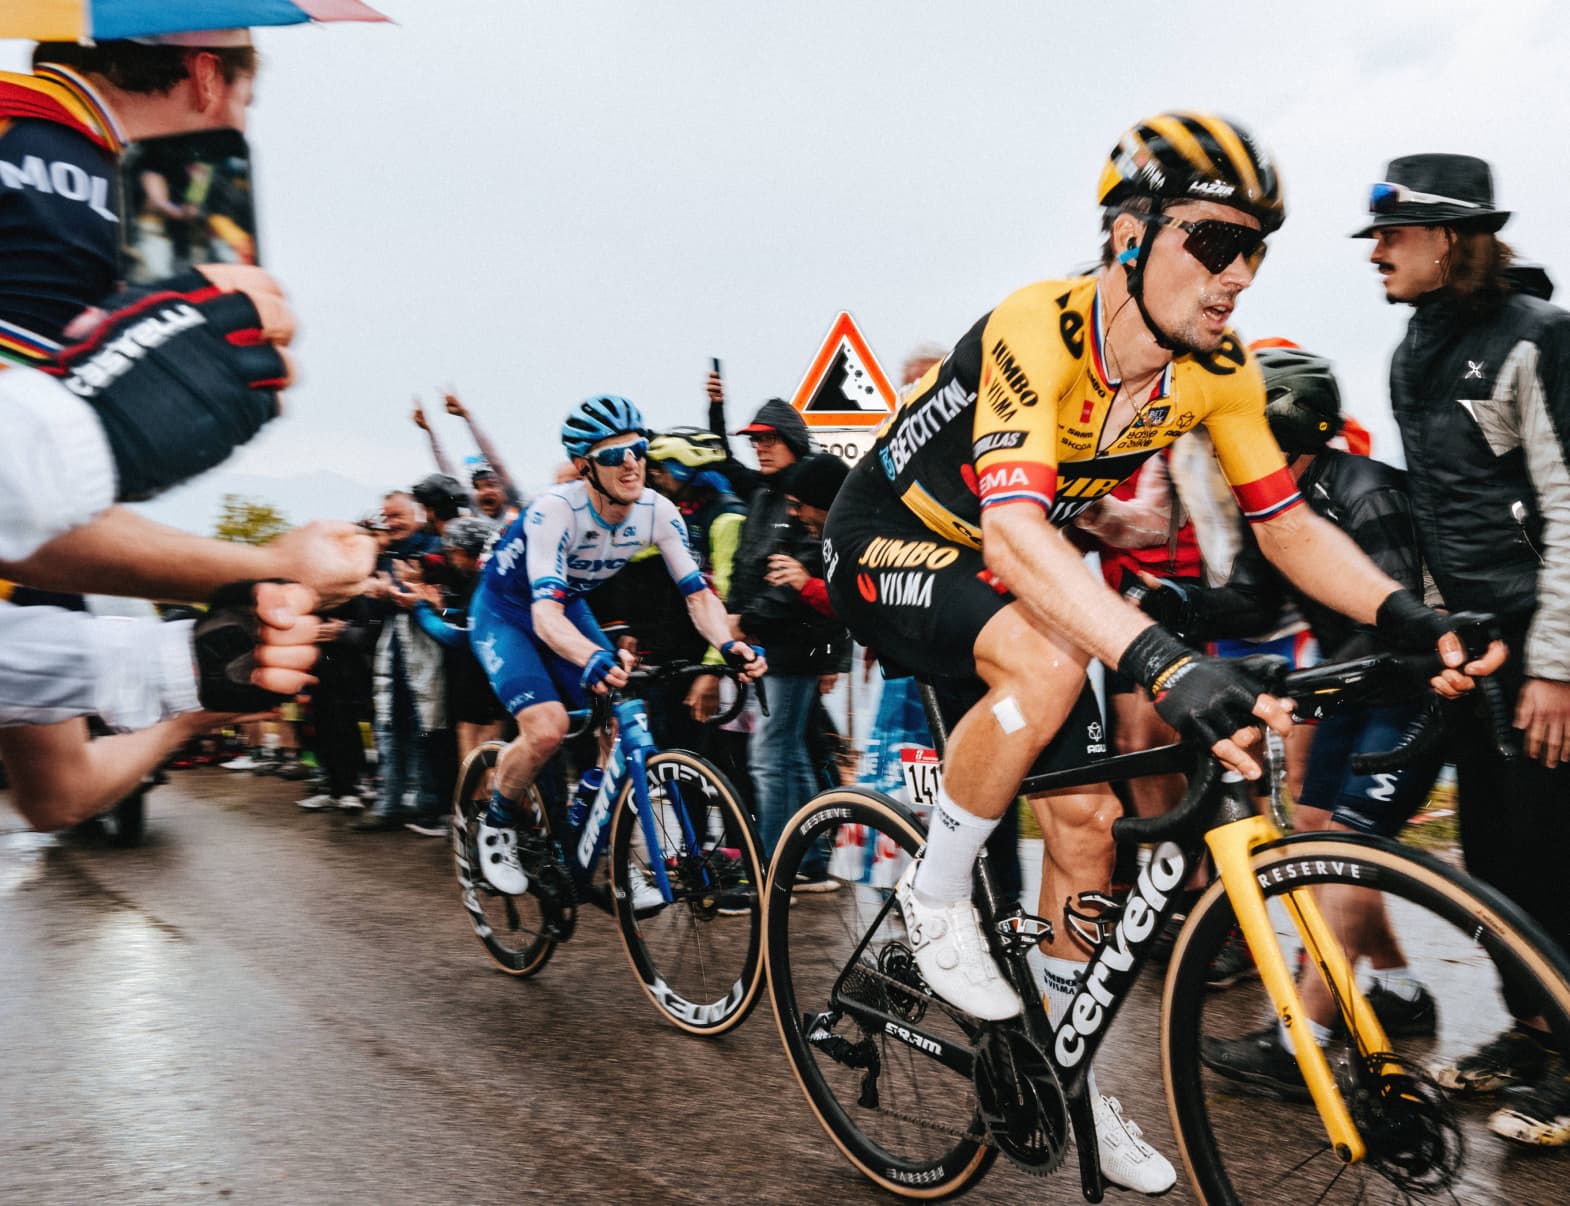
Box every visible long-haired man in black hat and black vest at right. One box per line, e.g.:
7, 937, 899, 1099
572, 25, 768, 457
1353, 154, 1570, 1146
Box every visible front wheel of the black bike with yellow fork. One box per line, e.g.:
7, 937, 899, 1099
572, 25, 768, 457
1162, 834, 1570, 1206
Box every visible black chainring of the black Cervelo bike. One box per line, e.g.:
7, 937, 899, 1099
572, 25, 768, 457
975, 1025, 1069, 1176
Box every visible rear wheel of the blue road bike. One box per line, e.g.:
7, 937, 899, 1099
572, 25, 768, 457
452, 741, 556, 975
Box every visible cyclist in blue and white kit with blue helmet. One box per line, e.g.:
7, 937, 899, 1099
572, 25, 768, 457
471, 396, 768, 895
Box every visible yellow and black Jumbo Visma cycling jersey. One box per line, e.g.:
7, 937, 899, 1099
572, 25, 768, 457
870, 276, 1302, 548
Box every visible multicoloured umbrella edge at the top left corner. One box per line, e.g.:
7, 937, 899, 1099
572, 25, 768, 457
0, 0, 386, 42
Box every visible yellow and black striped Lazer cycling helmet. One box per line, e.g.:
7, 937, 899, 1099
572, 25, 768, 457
1096, 113, 1286, 234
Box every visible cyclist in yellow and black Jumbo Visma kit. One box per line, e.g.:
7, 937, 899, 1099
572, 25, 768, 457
824, 113, 1502, 1192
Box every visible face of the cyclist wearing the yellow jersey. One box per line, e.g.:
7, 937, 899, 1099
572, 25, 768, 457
1145, 201, 1259, 352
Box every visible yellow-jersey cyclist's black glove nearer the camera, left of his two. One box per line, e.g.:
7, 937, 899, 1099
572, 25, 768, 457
1118, 623, 1269, 747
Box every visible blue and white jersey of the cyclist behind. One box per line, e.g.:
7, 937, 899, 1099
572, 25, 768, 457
484, 482, 707, 614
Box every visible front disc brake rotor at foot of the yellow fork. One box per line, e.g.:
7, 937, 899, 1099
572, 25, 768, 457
1347, 1055, 1466, 1195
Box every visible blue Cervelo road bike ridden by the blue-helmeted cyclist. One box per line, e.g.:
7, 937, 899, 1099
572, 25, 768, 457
452, 663, 768, 1035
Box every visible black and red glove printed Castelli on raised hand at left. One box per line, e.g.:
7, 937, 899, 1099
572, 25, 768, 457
39, 272, 286, 501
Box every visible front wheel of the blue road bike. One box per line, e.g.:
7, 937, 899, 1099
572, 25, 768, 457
611, 749, 763, 1035
